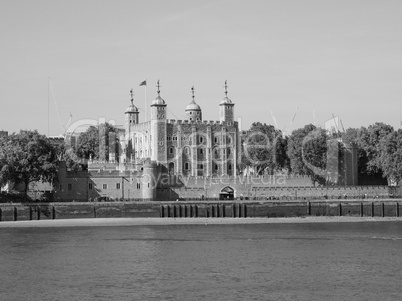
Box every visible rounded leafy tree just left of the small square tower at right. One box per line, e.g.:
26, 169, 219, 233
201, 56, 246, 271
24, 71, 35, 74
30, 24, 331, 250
287, 124, 327, 184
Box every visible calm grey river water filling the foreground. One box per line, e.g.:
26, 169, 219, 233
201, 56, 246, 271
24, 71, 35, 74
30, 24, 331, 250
0, 221, 402, 301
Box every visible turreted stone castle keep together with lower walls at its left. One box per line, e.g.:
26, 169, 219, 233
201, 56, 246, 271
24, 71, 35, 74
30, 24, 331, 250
56, 81, 245, 200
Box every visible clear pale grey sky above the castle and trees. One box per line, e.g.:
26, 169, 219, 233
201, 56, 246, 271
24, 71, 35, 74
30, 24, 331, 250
0, 0, 402, 135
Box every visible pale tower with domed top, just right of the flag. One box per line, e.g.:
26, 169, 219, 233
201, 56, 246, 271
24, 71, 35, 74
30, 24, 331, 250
150, 80, 167, 164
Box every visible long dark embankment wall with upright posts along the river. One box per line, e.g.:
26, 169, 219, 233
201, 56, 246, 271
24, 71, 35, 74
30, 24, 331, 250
0, 199, 402, 222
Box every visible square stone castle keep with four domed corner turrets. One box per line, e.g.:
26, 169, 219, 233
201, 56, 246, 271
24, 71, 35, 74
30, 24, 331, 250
119, 81, 239, 176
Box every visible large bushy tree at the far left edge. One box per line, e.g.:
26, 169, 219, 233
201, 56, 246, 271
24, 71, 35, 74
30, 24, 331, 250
0, 131, 57, 194
